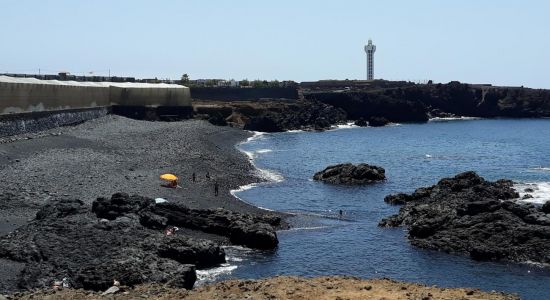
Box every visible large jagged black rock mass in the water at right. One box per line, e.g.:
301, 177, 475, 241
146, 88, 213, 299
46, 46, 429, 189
379, 172, 550, 264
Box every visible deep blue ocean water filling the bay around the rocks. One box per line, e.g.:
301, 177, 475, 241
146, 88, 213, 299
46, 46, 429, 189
205, 119, 550, 299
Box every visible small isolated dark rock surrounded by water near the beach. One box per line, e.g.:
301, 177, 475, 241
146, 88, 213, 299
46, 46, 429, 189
313, 163, 386, 185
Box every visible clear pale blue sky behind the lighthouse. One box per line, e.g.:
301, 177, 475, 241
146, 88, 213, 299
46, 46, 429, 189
0, 0, 550, 88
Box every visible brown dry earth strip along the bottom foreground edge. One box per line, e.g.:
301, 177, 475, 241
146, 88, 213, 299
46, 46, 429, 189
15, 276, 519, 300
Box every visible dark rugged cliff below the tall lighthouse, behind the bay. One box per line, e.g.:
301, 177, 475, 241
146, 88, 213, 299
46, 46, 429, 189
303, 81, 550, 122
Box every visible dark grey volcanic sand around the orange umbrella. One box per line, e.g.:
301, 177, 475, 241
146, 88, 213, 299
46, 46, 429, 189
0, 116, 274, 234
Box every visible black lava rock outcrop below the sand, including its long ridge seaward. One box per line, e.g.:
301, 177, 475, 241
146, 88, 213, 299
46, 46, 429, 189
0, 193, 281, 290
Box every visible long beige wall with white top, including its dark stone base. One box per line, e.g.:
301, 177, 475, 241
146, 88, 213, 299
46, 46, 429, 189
0, 76, 192, 137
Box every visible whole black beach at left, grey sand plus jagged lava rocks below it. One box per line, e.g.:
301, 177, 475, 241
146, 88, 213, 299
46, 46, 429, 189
0, 115, 284, 293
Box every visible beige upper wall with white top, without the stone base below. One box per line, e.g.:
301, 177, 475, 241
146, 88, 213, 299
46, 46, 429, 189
0, 76, 191, 115
